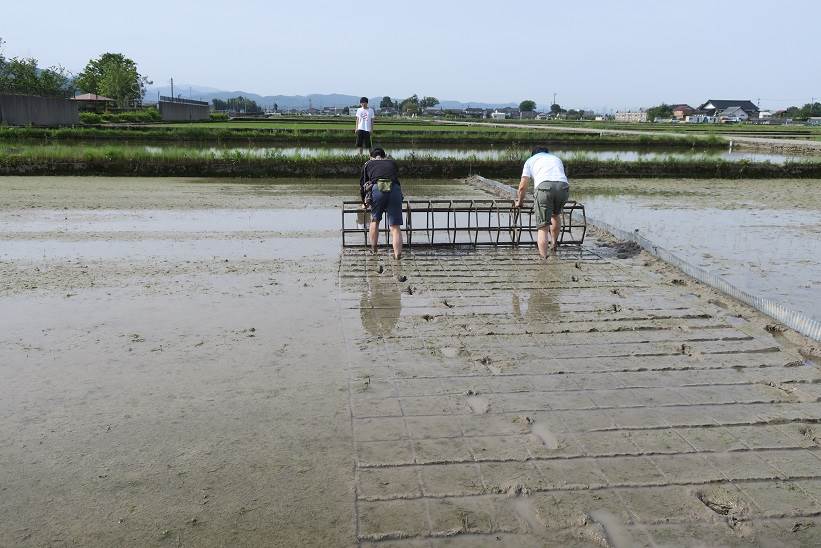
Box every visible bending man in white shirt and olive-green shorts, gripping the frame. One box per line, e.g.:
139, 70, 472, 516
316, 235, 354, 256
516, 147, 570, 259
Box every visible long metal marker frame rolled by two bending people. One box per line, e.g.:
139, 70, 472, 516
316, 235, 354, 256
342, 199, 587, 247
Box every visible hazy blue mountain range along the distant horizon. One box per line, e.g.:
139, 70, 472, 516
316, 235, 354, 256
145, 84, 519, 110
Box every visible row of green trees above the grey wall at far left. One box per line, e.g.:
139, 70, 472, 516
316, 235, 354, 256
0, 38, 152, 107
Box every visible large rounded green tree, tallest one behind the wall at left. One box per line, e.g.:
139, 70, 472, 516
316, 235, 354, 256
77, 53, 151, 106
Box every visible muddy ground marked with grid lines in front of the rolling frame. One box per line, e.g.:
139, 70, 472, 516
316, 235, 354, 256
339, 245, 821, 546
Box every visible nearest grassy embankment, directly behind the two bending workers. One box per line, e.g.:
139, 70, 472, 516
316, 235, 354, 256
0, 145, 821, 179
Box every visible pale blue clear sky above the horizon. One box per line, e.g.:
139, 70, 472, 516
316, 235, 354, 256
0, 0, 821, 110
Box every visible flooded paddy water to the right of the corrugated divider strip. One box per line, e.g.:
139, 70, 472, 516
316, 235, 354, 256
583, 192, 821, 319
